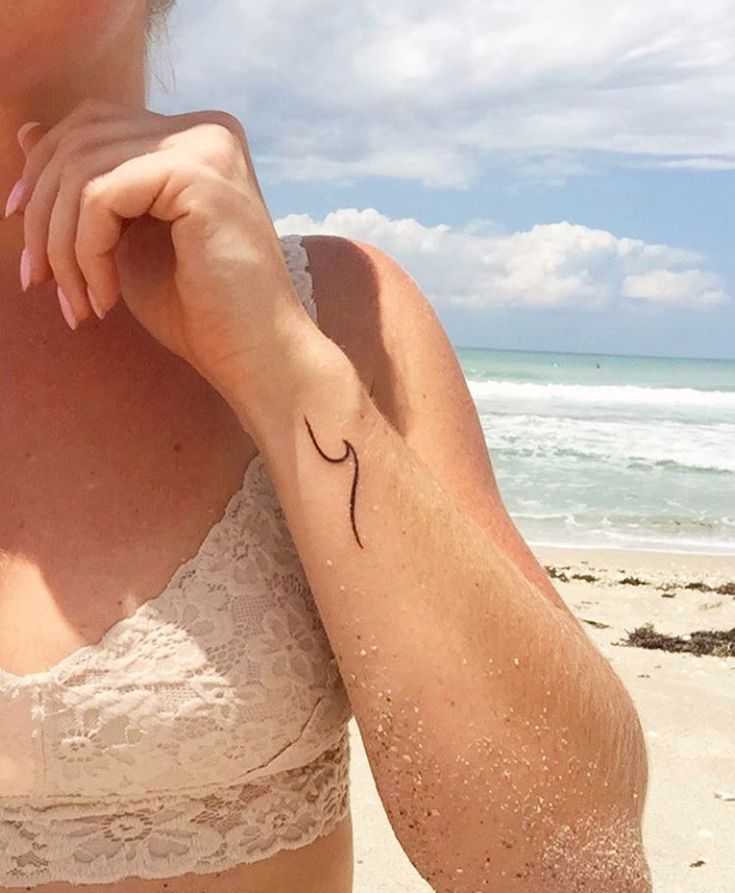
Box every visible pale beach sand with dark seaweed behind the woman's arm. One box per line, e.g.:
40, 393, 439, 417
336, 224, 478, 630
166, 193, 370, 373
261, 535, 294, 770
350, 546, 735, 893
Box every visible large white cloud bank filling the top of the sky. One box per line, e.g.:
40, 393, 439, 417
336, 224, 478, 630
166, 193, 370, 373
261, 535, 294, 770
154, 0, 735, 188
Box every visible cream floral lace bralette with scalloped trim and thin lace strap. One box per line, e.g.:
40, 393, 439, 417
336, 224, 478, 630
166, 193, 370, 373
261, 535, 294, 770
0, 236, 352, 887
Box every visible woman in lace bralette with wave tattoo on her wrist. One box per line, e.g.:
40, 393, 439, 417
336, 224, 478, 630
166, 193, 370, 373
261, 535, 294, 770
0, 0, 650, 893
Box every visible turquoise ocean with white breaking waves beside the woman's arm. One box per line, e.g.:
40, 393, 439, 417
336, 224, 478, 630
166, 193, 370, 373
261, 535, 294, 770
455, 347, 735, 554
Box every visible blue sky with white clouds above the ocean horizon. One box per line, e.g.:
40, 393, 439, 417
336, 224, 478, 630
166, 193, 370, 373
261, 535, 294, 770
149, 0, 735, 359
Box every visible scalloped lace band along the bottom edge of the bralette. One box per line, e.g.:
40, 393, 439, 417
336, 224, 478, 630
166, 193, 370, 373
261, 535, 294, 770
0, 729, 350, 887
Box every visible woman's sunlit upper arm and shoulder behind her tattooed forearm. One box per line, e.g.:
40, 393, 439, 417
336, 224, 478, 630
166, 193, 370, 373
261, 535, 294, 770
316, 233, 571, 614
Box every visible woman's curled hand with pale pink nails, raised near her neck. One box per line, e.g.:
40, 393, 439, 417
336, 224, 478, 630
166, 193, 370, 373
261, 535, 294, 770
6, 99, 313, 387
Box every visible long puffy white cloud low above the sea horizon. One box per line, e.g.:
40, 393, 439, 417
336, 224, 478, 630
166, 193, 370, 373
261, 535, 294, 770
274, 208, 727, 311
